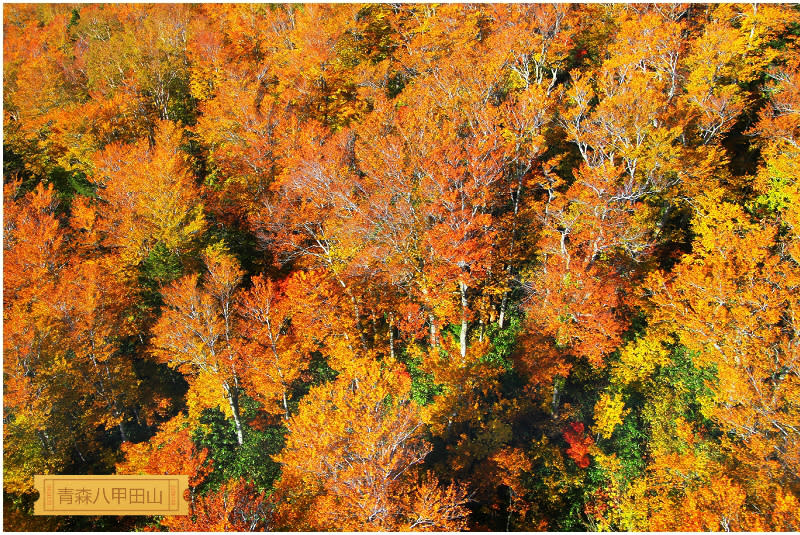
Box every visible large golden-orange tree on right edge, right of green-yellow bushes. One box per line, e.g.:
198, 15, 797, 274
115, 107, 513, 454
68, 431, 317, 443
648, 193, 800, 504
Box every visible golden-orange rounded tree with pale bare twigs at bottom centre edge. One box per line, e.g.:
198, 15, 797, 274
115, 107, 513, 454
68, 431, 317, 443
276, 360, 466, 530
